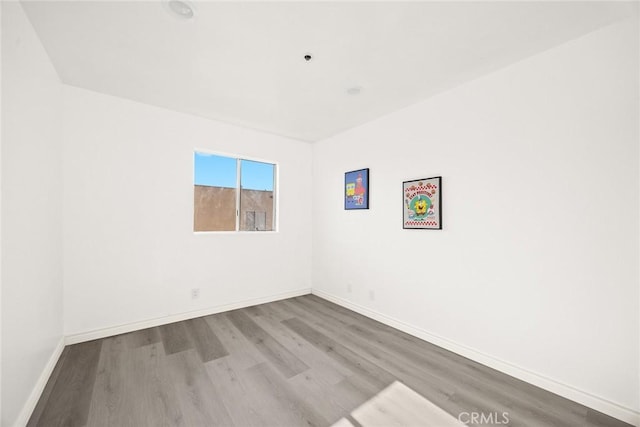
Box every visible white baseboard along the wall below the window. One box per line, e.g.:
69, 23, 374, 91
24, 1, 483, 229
65, 288, 311, 345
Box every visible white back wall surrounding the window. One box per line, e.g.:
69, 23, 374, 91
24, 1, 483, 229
64, 86, 312, 335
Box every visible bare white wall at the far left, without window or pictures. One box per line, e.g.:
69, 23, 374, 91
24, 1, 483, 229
1, 2, 63, 426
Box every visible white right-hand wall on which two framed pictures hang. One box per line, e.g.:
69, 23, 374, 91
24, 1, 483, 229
312, 16, 640, 418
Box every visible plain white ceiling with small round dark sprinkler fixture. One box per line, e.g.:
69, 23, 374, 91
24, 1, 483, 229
23, 0, 637, 141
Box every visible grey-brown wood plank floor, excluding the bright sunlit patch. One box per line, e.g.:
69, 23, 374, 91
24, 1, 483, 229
29, 295, 628, 427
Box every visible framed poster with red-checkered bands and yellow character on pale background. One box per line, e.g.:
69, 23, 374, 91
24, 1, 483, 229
402, 176, 442, 230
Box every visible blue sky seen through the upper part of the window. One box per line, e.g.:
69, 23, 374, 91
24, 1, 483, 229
194, 152, 274, 191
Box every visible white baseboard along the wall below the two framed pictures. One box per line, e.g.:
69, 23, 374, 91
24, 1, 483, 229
311, 289, 640, 426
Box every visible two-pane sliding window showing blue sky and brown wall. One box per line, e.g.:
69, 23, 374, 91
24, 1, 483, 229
193, 151, 276, 231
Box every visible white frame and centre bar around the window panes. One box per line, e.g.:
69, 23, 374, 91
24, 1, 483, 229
191, 148, 280, 235
